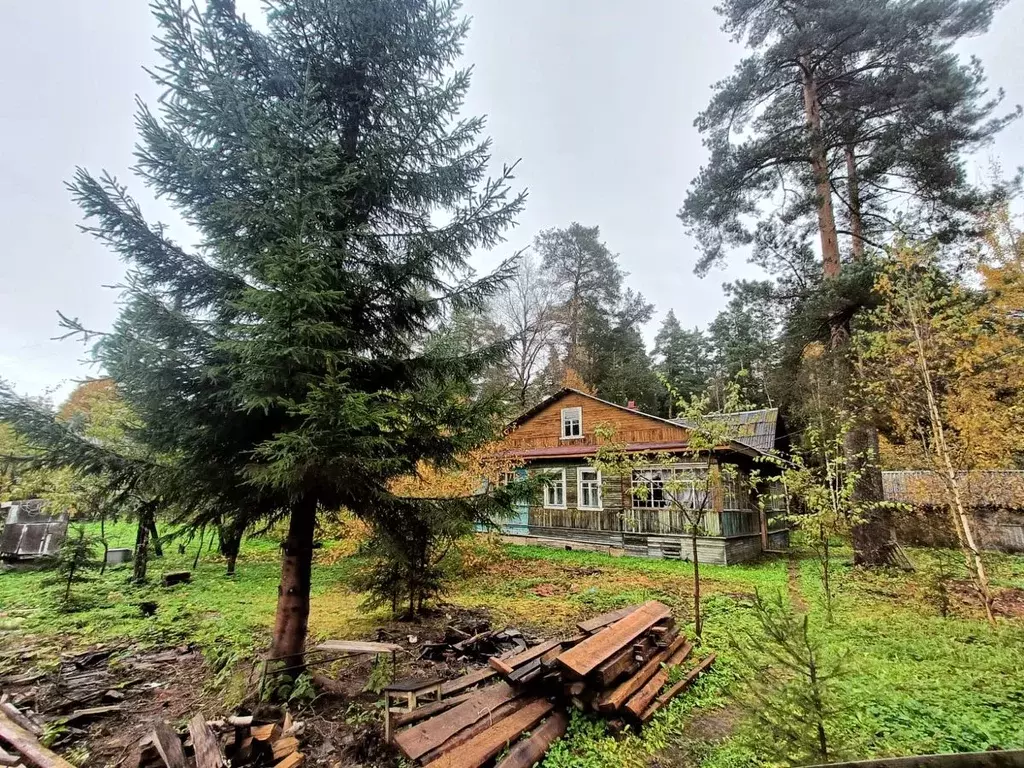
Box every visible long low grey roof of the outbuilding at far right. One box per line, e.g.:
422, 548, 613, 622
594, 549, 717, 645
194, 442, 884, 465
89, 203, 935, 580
882, 469, 1024, 509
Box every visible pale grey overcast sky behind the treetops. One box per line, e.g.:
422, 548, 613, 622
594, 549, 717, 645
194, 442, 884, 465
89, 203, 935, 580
0, 0, 1024, 397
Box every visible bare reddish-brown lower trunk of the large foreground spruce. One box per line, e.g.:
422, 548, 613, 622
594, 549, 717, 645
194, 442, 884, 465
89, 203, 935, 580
270, 500, 316, 677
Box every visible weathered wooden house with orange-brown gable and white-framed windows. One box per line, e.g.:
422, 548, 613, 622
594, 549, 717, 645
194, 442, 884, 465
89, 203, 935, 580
483, 388, 788, 565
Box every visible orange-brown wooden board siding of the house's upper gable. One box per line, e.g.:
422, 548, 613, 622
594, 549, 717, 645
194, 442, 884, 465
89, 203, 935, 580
499, 393, 689, 451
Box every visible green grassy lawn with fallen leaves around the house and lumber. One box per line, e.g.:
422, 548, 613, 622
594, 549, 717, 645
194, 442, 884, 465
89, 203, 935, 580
0, 526, 1024, 768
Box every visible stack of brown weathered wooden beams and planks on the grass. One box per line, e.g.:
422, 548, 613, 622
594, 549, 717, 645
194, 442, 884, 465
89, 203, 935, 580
385, 601, 715, 768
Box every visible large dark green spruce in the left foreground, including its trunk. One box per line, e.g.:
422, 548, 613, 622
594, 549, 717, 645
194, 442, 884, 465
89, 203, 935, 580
66, 0, 524, 670
